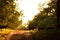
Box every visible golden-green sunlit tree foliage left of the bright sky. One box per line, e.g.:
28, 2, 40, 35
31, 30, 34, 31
0, 0, 22, 29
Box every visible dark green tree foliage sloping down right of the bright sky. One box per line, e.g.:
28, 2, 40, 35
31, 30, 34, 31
28, 0, 57, 29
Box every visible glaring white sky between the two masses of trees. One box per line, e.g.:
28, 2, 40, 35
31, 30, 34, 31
14, 0, 50, 25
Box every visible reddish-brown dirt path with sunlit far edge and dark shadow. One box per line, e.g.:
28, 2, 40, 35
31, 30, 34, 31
6, 30, 32, 40
